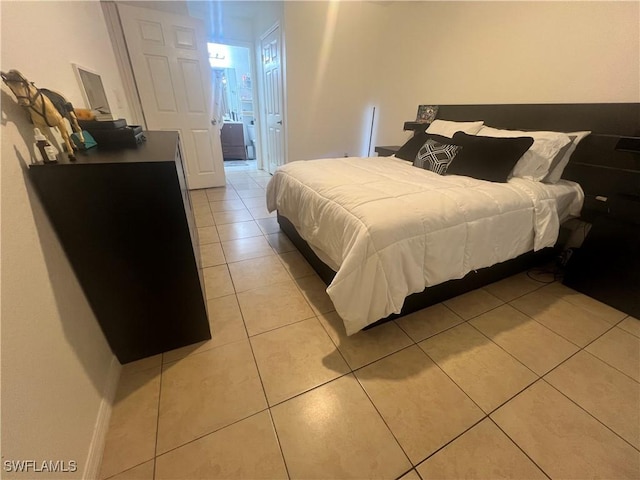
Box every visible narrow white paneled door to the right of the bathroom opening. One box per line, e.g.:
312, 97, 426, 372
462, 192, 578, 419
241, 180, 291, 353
261, 26, 284, 173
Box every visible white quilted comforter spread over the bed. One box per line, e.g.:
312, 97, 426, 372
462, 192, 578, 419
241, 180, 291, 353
267, 157, 580, 335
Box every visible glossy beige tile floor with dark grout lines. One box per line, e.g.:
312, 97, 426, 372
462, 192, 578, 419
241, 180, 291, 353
101, 169, 640, 480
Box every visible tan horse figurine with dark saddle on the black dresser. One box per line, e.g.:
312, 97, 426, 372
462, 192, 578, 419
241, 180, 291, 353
0, 70, 84, 160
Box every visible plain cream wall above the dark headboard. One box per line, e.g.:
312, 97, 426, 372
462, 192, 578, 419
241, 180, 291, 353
378, 1, 640, 144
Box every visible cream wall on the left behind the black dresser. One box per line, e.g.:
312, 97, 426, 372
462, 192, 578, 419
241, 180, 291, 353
0, 1, 128, 478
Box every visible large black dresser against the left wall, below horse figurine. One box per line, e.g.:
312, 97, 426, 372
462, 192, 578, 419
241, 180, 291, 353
29, 132, 211, 363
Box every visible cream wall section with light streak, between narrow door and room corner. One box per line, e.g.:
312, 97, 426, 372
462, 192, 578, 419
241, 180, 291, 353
284, 2, 382, 161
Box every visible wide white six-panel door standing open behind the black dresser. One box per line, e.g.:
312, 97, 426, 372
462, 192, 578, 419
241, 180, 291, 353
118, 5, 225, 189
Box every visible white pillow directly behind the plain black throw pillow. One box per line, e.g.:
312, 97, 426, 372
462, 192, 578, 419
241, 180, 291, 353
478, 126, 571, 182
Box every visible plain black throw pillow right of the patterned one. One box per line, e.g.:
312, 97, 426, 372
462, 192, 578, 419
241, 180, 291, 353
447, 132, 533, 183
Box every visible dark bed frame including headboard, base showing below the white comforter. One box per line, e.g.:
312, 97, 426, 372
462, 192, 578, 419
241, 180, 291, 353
277, 103, 640, 328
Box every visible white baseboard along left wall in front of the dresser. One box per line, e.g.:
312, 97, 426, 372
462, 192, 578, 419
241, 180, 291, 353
83, 355, 122, 480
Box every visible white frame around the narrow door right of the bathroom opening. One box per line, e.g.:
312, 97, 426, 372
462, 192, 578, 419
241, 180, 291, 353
255, 20, 289, 172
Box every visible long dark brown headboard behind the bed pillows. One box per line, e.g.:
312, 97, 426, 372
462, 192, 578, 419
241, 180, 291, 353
436, 103, 640, 196
